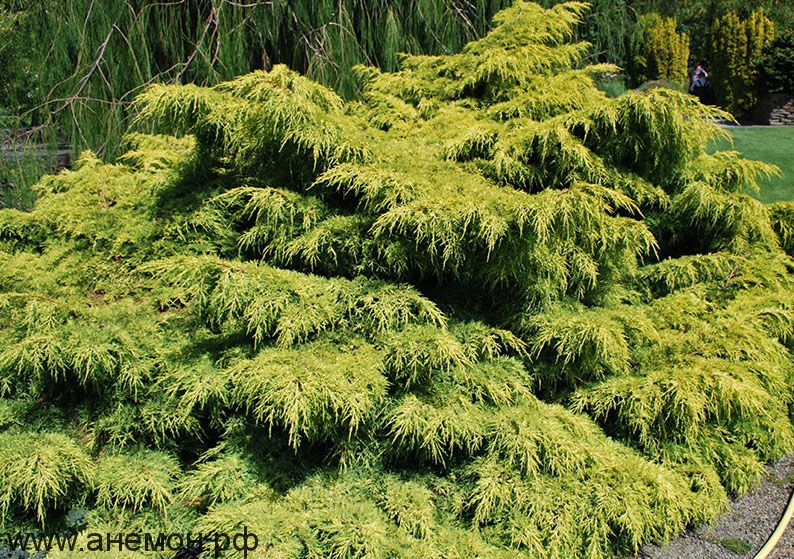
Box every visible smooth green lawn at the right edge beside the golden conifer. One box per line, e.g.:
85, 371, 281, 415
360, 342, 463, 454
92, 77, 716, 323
718, 126, 794, 202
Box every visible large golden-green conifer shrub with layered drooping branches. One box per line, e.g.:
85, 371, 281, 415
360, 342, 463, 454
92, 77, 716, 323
0, 1, 794, 559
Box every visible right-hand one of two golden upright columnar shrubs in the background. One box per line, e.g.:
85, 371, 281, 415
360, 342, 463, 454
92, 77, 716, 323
709, 9, 775, 113
